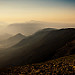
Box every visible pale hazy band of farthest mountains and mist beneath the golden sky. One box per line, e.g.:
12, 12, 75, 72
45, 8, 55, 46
0, 20, 75, 36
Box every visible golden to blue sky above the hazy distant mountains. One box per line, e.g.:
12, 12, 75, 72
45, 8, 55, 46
0, 0, 75, 25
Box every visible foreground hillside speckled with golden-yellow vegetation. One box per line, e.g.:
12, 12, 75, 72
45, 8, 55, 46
0, 55, 75, 75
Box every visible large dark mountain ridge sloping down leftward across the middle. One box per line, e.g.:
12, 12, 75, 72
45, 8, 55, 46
0, 28, 75, 67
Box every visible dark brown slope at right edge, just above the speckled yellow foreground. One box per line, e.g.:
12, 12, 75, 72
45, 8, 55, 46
53, 40, 75, 58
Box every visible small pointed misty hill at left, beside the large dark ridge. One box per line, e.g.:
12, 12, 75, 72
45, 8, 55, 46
0, 33, 25, 48
